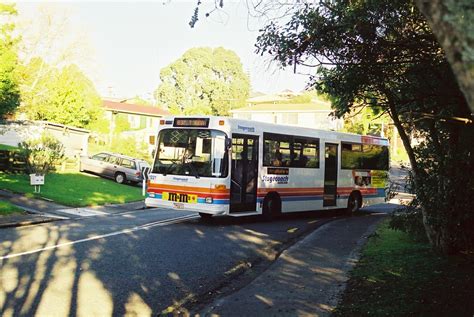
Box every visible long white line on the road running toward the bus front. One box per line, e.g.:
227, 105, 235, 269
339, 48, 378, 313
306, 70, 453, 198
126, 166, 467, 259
0, 215, 199, 261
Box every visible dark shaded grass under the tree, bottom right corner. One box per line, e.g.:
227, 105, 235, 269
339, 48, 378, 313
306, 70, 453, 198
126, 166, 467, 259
334, 222, 474, 316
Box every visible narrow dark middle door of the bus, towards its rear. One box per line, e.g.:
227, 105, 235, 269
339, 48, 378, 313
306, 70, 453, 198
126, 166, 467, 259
323, 143, 338, 206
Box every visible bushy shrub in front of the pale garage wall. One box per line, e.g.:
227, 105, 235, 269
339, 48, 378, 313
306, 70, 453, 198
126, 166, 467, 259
19, 132, 64, 174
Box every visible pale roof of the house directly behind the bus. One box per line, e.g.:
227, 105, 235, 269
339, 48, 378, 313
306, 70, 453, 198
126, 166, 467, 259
231, 101, 331, 113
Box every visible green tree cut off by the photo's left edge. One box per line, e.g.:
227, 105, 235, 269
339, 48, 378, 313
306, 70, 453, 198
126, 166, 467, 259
0, 3, 20, 119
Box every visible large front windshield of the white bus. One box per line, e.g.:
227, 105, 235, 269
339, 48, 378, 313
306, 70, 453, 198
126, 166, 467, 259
153, 129, 228, 178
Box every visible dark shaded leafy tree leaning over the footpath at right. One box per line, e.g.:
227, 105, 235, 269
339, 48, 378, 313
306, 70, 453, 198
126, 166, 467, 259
256, 0, 474, 253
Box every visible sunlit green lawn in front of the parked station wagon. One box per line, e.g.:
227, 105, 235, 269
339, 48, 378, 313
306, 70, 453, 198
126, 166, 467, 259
0, 172, 143, 207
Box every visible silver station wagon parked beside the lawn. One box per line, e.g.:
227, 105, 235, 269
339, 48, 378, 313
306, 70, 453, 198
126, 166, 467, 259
79, 152, 150, 184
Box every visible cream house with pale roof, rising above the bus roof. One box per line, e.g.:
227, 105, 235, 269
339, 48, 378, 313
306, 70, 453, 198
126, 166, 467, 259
231, 98, 344, 131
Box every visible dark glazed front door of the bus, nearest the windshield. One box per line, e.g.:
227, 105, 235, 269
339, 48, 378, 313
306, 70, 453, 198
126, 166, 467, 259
230, 134, 258, 213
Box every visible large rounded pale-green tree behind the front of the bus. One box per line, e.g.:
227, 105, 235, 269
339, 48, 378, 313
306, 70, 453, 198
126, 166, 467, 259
155, 47, 250, 115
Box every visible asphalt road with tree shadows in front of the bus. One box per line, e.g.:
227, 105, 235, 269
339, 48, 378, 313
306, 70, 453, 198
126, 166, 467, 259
0, 206, 391, 316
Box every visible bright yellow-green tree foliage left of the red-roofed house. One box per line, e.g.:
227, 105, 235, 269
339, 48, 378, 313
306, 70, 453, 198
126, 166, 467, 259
21, 58, 102, 128
